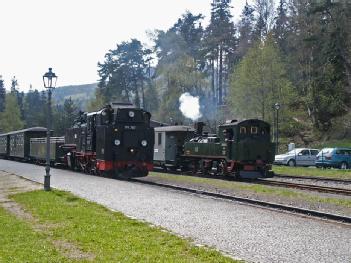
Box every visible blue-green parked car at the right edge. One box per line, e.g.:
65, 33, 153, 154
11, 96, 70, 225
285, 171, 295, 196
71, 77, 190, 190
315, 147, 351, 169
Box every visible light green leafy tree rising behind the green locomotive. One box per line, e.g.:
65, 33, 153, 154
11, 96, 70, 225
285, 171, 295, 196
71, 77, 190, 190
231, 36, 293, 126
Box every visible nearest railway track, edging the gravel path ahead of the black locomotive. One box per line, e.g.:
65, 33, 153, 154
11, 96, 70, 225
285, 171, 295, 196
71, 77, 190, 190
128, 179, 351, 224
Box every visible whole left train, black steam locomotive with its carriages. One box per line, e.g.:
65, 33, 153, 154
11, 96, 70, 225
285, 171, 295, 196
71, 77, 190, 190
0, 103, 154, 178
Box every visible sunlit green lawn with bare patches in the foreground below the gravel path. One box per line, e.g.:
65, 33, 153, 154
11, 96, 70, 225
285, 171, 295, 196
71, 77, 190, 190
0, 191, 237, 262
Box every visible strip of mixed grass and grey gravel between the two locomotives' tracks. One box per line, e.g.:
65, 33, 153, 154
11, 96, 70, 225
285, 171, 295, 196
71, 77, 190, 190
139, 173, 351, 217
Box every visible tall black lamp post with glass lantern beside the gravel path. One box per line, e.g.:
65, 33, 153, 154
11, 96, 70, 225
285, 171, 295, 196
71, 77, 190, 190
43, 68, 57, 191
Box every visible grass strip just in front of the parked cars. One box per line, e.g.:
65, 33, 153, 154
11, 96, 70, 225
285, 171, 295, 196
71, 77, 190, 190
273, 165, 351, 179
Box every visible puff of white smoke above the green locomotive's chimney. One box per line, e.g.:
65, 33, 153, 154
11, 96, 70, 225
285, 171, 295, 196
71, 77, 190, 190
179, 92, 202, 121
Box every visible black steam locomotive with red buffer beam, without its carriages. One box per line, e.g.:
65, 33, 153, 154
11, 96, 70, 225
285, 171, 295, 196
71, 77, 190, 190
62, 103, 154, 177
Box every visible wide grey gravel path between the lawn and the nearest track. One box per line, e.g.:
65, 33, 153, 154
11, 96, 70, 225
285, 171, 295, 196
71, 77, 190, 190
0, 160, 351, 262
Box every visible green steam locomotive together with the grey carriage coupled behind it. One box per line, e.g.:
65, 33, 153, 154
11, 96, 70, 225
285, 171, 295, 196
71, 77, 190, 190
154, 119, 275, 178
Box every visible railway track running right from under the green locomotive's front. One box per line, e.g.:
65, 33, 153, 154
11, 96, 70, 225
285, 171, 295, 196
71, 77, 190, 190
255, 179, 351, 196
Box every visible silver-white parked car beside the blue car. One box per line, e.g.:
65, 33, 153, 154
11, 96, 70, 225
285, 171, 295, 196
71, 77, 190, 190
274, 148, 319, 166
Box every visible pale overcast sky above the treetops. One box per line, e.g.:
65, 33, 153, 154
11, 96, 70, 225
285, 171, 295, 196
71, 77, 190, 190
0, 0, 245, 91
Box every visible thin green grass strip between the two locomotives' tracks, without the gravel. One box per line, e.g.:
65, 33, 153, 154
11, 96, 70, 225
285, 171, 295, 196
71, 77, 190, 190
150, 172, 351, 208
